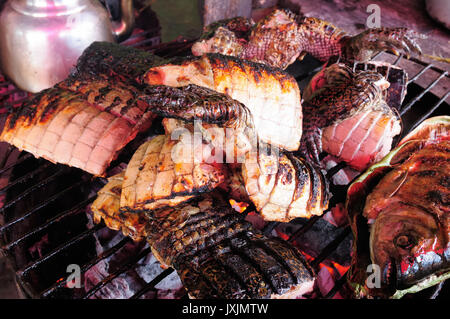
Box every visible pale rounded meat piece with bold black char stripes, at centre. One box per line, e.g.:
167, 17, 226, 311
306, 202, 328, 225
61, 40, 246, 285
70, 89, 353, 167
242, 146, 329, 222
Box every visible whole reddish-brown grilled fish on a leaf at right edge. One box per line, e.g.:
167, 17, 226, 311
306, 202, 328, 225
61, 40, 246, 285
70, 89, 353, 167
347, 116, 450, 298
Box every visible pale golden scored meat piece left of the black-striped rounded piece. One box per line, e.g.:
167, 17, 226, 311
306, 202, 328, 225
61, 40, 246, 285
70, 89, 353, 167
120, 131, 225, 211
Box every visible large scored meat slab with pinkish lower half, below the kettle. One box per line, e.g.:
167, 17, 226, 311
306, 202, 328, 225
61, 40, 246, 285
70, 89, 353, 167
0, 42, 172, 175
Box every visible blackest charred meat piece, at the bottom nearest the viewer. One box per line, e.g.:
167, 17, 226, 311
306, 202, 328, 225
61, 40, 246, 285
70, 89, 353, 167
177, 231, 314, 299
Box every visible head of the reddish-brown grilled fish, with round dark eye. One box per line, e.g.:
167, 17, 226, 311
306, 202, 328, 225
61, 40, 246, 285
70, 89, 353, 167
370, 202, 450, 293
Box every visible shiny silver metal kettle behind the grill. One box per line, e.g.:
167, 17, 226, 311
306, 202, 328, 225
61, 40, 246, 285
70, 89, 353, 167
0, 0, 134, 92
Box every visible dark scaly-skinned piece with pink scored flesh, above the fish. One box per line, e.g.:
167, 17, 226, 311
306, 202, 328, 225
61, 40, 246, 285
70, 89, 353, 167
302, 64, 400, 170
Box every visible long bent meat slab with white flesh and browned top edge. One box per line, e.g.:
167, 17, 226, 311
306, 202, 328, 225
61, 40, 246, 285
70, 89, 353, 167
143, 54, 302, 151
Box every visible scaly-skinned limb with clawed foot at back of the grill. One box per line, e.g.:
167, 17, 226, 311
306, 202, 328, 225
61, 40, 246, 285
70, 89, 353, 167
192, 9, 423, 69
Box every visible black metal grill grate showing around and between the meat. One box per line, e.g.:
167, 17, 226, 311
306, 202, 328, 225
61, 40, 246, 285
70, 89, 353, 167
0, 41, 449, 299
